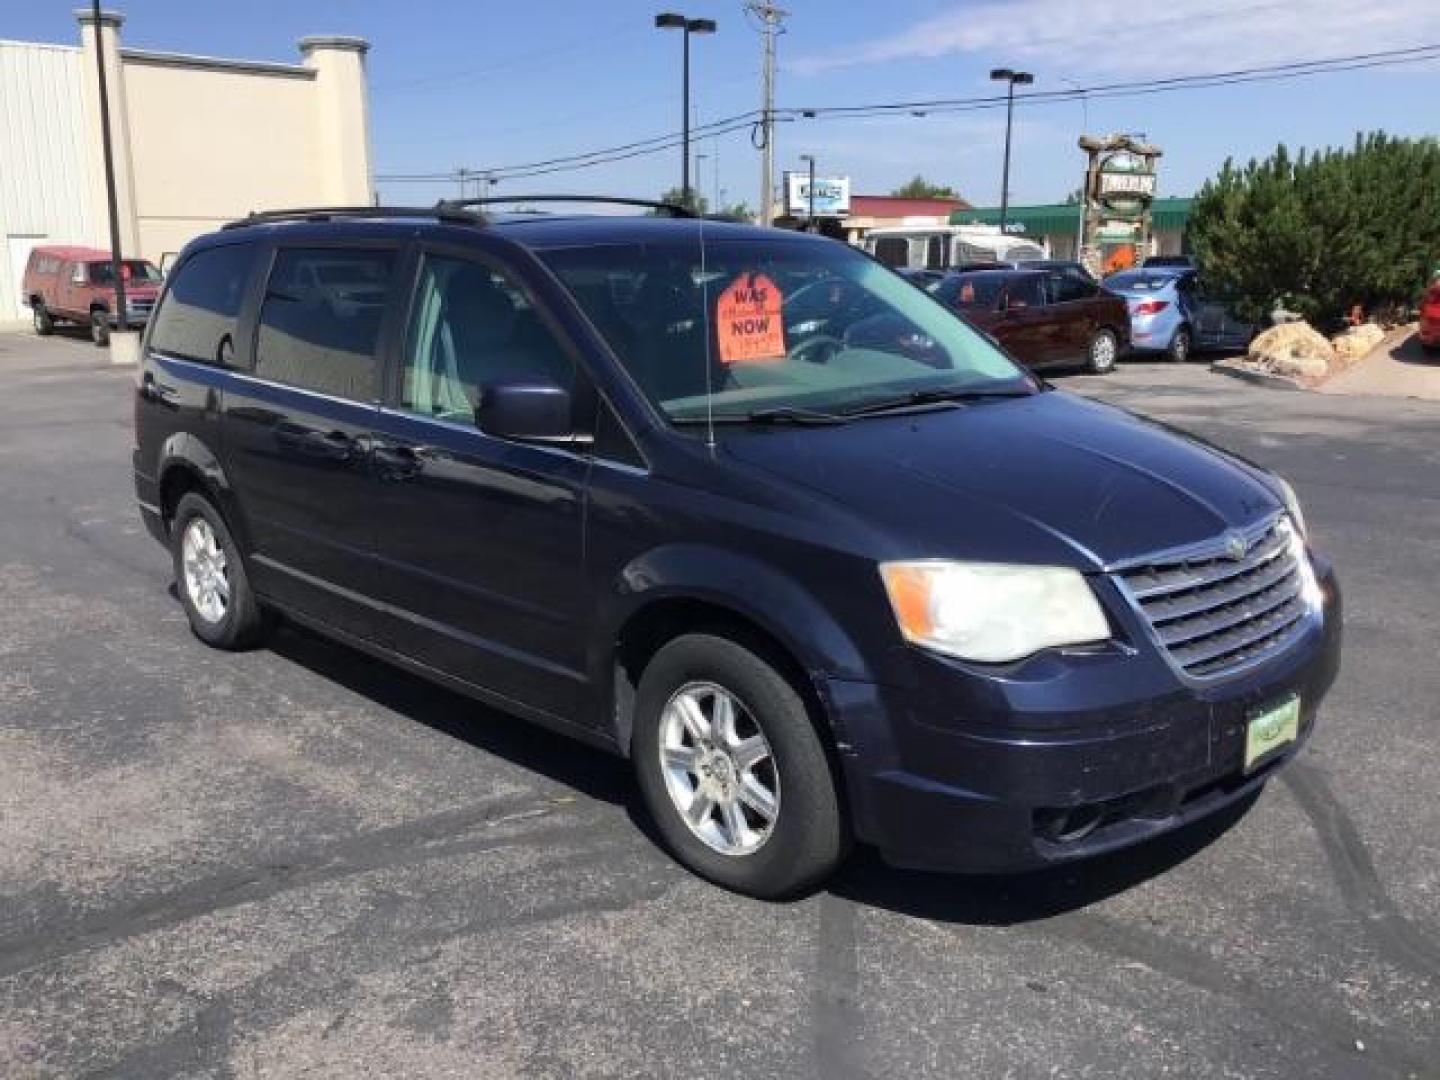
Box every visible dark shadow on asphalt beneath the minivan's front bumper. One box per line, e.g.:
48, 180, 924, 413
829, 792, 1259, 926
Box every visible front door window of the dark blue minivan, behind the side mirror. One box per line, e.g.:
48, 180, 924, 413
400, 255, 575, 423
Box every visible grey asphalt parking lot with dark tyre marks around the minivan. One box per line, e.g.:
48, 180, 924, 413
0, 333, 1440, 1080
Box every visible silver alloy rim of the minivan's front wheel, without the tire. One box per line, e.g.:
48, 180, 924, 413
660, 683, 780, 855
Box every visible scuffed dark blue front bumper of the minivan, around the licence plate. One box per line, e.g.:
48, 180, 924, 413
825, 560, 1341, 873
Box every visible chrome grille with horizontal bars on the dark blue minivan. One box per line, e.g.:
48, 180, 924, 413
1115, 516, 1313, 678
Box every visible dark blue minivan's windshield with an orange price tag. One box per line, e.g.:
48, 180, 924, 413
537, 236, 1034, 422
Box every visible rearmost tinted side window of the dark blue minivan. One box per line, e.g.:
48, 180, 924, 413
150, 243, 258, 364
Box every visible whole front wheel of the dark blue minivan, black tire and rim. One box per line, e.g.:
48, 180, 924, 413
631, 634, 850, 900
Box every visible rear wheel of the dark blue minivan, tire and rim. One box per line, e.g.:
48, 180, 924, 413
170, 491, 268, 651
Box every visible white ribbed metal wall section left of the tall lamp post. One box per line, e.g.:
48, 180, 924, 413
0, 42, 102, 323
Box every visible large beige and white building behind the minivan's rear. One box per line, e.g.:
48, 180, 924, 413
0, 9, 374, 323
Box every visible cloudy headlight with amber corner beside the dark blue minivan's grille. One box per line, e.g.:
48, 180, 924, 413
880, 560, 1110, 662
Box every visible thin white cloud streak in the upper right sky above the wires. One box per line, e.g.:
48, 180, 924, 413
785, 0, 1436, 79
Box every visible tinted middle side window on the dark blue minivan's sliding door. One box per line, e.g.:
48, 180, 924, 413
255, 248, 396, 402
